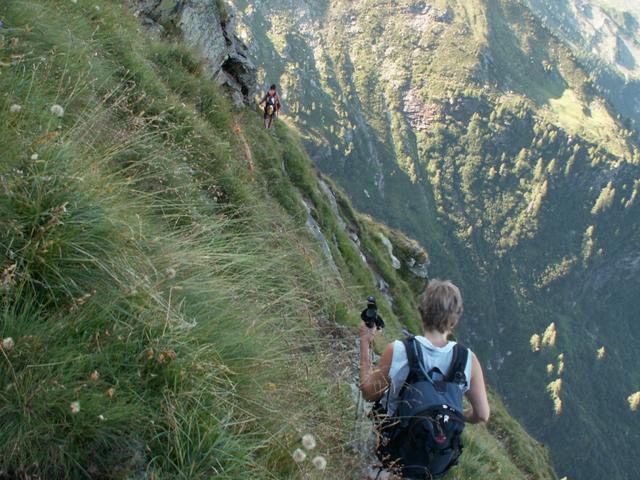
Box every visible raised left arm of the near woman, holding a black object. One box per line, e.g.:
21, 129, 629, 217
360, 323, 393, 402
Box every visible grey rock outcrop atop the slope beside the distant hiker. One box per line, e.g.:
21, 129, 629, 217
131, 0, 257, 104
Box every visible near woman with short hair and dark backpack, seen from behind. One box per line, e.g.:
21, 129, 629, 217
360, 280, 489, 479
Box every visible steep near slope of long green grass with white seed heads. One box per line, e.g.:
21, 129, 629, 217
0, 0, 555, 480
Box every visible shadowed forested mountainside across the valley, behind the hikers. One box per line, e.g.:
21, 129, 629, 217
232, 0, 640, 479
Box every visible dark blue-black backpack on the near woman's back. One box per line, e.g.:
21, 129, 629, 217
376, 337, 469, 479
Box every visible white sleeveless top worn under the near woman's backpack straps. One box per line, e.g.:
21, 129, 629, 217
380, 336, 473, 415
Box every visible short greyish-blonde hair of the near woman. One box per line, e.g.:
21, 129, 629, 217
418, 279, 463, 333
